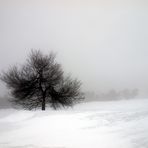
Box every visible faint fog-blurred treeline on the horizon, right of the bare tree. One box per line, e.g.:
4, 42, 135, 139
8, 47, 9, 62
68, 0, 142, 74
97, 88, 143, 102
85, 88, 139, 101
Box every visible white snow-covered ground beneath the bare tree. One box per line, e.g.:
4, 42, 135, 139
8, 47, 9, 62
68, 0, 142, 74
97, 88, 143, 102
0, 99, 148, 148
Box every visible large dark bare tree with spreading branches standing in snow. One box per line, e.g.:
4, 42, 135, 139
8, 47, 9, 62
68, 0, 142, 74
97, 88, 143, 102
1, 50, 84, 110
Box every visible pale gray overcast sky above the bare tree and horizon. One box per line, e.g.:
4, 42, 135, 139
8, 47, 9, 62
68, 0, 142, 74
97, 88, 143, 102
0, 0, 148, 94
